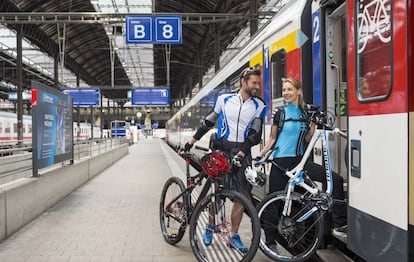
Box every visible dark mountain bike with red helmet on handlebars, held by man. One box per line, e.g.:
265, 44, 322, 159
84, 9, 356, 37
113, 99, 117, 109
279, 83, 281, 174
160, 146, 260, 261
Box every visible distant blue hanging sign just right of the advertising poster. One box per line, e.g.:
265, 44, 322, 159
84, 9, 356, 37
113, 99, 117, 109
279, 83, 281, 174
61, 88, 100, 106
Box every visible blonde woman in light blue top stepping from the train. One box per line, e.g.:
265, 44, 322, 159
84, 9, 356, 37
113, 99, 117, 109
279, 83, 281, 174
259, 78, 346, 248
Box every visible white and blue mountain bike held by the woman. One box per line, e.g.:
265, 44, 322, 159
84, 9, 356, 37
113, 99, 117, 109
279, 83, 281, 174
255, 106, 346, 262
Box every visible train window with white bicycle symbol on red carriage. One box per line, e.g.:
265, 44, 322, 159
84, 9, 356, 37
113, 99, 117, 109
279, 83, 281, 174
355, 0, 392, 101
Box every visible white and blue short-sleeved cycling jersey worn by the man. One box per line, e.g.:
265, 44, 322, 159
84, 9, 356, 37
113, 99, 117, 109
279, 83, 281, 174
213, 94, 266, 143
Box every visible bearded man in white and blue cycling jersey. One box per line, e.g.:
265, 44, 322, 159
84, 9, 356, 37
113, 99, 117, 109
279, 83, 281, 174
185, 67, 266, 252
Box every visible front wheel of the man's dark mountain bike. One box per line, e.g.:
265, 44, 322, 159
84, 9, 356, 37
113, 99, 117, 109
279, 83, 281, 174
190, 190, 260, 262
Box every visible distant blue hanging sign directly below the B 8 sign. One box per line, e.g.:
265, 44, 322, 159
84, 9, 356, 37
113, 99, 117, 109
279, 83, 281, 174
131, 87, 170, 105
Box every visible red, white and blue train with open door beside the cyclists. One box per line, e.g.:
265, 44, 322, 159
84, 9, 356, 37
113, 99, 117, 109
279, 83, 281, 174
166, 0, 414, 261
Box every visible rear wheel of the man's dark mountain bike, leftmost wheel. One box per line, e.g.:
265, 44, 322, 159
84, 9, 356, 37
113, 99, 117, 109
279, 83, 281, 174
160, 177, 187, 245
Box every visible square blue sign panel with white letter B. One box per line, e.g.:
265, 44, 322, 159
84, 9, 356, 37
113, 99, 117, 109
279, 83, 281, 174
126, 16, 153, 44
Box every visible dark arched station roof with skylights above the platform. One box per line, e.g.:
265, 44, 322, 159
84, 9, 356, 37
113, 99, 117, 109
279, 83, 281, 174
0, 0, 286, 103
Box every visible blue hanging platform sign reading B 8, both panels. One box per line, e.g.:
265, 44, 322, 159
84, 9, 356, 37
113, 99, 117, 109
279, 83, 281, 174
125, 16, 182, 44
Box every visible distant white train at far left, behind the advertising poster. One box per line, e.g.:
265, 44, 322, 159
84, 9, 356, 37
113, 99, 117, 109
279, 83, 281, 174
0, 111, 101, 149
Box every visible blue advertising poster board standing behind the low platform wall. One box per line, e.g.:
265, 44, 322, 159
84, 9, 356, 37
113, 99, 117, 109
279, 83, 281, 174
32, 81, 73, 176
